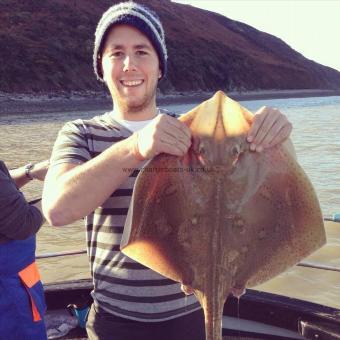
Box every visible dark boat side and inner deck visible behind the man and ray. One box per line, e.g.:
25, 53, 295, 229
45, 279, 340, 340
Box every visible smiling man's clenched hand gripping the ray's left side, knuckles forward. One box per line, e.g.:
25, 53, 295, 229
137, 114, 191, 159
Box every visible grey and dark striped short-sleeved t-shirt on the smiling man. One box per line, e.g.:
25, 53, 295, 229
51, 112, 200, 321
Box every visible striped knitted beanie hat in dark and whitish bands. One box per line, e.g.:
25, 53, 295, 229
93, 1, 168, 81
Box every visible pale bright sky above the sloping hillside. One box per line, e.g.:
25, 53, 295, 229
174, 0, 340, 71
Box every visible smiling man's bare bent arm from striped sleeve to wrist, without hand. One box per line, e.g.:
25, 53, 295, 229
42, 137, 140, 226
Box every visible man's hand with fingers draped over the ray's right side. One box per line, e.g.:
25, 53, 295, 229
247, 106, 293, 152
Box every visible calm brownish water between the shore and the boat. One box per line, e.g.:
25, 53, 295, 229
0, 97, 340, 308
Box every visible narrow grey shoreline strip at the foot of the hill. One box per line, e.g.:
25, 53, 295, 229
0, 89, 340, 116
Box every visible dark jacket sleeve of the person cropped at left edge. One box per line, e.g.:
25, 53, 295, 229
0, 160, 43, 244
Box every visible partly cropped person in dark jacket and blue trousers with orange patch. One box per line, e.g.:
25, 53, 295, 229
0, 160, 49, 340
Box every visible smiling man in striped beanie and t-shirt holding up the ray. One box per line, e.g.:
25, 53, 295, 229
43, 2, 291, 340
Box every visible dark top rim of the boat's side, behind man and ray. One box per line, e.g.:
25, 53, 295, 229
44, 279, 340, 332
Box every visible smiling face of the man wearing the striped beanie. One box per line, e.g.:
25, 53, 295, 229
102, 25, 161, 112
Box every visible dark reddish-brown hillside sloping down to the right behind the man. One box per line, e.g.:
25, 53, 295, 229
0, 0, 340, 93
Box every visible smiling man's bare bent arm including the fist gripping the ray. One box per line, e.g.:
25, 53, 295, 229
42, 115, 191, 226
